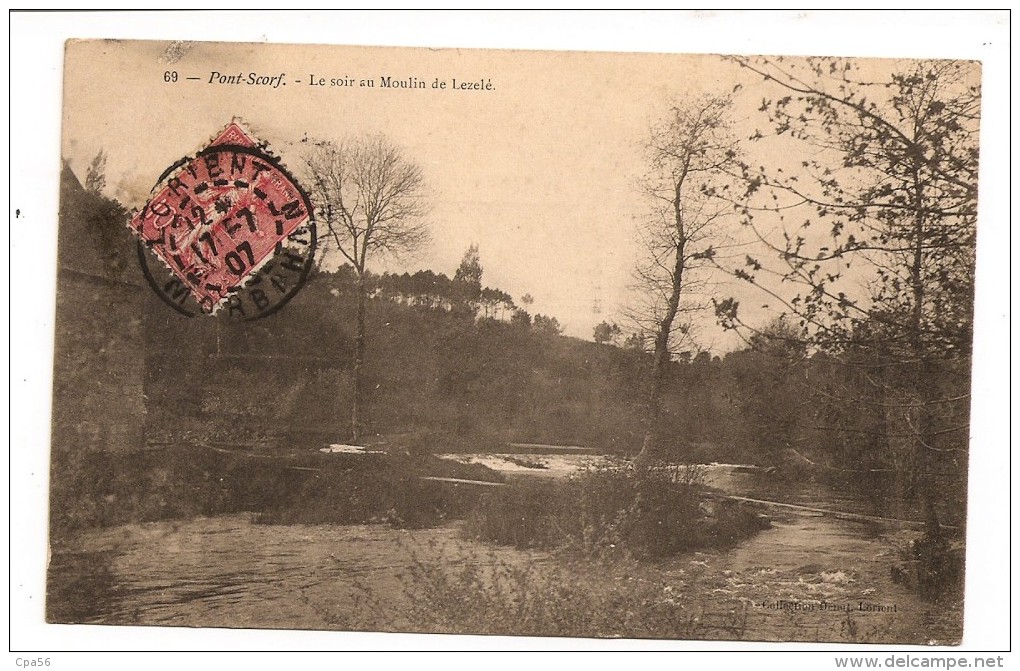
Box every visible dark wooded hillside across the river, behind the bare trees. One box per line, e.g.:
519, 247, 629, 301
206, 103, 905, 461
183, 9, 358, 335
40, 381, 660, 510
147, 259, 968, 489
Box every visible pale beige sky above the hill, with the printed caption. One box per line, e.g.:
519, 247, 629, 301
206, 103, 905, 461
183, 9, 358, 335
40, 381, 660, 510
62, 41, 787, 350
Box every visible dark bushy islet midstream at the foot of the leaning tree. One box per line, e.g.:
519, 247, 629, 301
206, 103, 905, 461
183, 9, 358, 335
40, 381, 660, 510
465, 467, 761, 558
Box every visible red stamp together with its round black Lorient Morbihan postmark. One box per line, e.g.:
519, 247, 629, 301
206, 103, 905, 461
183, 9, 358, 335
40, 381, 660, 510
131, 130, 316, 320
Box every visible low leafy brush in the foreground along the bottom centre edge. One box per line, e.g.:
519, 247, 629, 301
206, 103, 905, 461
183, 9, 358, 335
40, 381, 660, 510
315, 534, 749, 639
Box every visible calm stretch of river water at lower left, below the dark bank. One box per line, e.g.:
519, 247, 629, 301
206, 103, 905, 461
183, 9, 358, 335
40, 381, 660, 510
49, 514, 489, 628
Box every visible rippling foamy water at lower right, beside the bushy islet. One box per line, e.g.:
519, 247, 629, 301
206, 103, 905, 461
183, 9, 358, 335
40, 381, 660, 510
652, 501, 963, 644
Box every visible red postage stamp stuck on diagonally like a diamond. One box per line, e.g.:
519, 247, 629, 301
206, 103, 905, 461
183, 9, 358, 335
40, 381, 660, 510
131, 122, 312, 314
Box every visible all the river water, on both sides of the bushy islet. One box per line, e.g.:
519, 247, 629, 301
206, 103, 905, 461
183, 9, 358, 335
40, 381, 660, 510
48, 456, 962, 643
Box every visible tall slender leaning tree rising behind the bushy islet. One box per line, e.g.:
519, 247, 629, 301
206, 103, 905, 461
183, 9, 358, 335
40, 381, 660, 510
630, 96, 737, 466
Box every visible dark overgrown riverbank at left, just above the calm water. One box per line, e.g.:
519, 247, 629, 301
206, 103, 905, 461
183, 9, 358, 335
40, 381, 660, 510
50, 446, 503, 540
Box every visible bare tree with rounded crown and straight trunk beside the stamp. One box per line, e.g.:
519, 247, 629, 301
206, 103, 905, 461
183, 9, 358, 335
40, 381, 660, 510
305, 135, 429, 442
